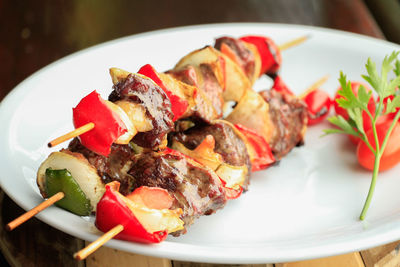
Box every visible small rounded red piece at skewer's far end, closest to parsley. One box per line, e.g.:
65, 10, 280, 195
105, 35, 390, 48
304, 89, 332, 125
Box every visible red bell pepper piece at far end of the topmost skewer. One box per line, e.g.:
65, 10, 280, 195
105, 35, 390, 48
240, 35, 282, 76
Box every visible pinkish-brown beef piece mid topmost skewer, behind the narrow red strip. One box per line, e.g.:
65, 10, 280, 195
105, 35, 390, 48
168, 64, 224, 118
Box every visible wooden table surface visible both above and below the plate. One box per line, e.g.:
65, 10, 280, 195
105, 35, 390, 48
0, 0, 398, 267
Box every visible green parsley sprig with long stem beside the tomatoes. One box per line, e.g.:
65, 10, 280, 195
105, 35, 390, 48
324, 51, 400, 220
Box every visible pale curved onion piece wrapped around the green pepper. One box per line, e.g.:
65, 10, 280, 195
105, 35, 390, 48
36, 150, 105, 211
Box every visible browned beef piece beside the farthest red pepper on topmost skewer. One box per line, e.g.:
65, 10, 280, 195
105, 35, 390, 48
214, 37, 255, 79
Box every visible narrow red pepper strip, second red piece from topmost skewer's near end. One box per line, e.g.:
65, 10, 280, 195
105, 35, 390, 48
138, 64, 189, 121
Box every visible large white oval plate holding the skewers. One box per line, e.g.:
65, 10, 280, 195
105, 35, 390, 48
0, 24, 400, 263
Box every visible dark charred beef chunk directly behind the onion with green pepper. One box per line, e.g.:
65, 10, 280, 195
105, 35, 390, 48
68, 138, 134, 195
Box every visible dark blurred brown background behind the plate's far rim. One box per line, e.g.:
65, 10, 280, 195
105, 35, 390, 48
0, 0, 394, 102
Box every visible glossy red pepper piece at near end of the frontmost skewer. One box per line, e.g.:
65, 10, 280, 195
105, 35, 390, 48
95, 185, 168, 243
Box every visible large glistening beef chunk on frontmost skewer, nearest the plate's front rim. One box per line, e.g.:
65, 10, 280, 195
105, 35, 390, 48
129, 152, 226, 236
